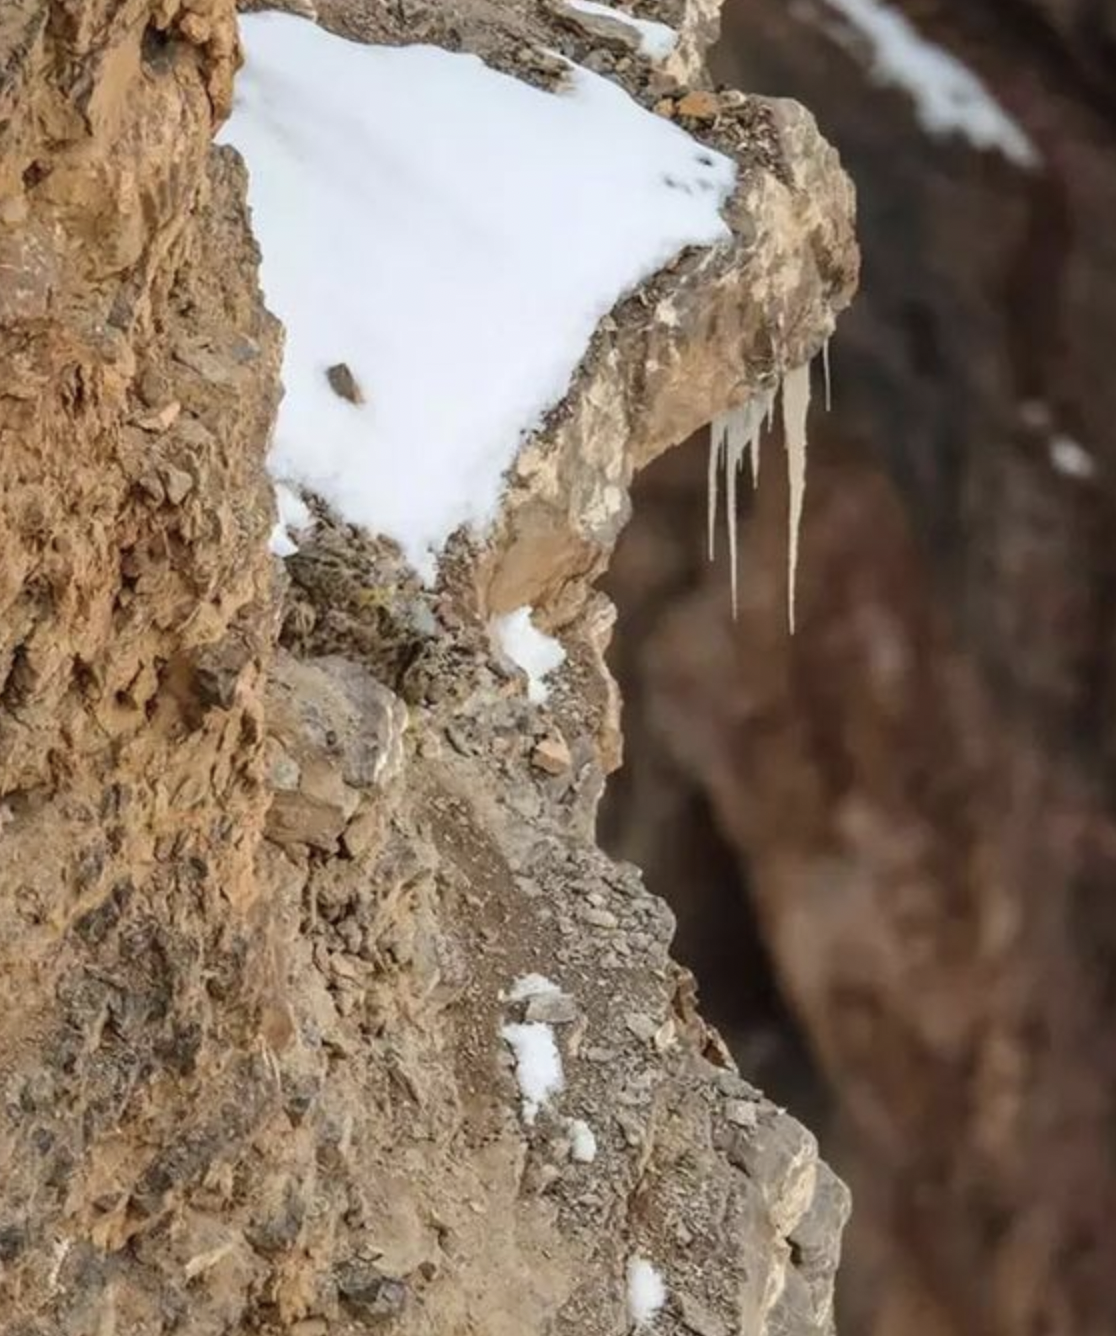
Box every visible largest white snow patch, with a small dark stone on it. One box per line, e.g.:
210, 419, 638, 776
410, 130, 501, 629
221, 13, 735, 580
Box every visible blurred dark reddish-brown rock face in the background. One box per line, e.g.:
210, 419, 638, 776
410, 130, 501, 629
609, 0, 1116, 1336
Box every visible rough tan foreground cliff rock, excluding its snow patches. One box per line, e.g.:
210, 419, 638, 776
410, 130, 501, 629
0, 0, 855, 1336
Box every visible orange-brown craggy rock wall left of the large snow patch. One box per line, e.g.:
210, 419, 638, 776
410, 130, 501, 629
0, 0, 288, 1332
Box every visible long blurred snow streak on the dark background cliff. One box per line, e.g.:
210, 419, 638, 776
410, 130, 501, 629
826, 0, 1041, 170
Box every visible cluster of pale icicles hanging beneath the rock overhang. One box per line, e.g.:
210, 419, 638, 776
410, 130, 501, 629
708, 345, 830, 635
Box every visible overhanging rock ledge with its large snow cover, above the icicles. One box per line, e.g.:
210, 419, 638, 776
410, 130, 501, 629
229, 0, 858, 627
